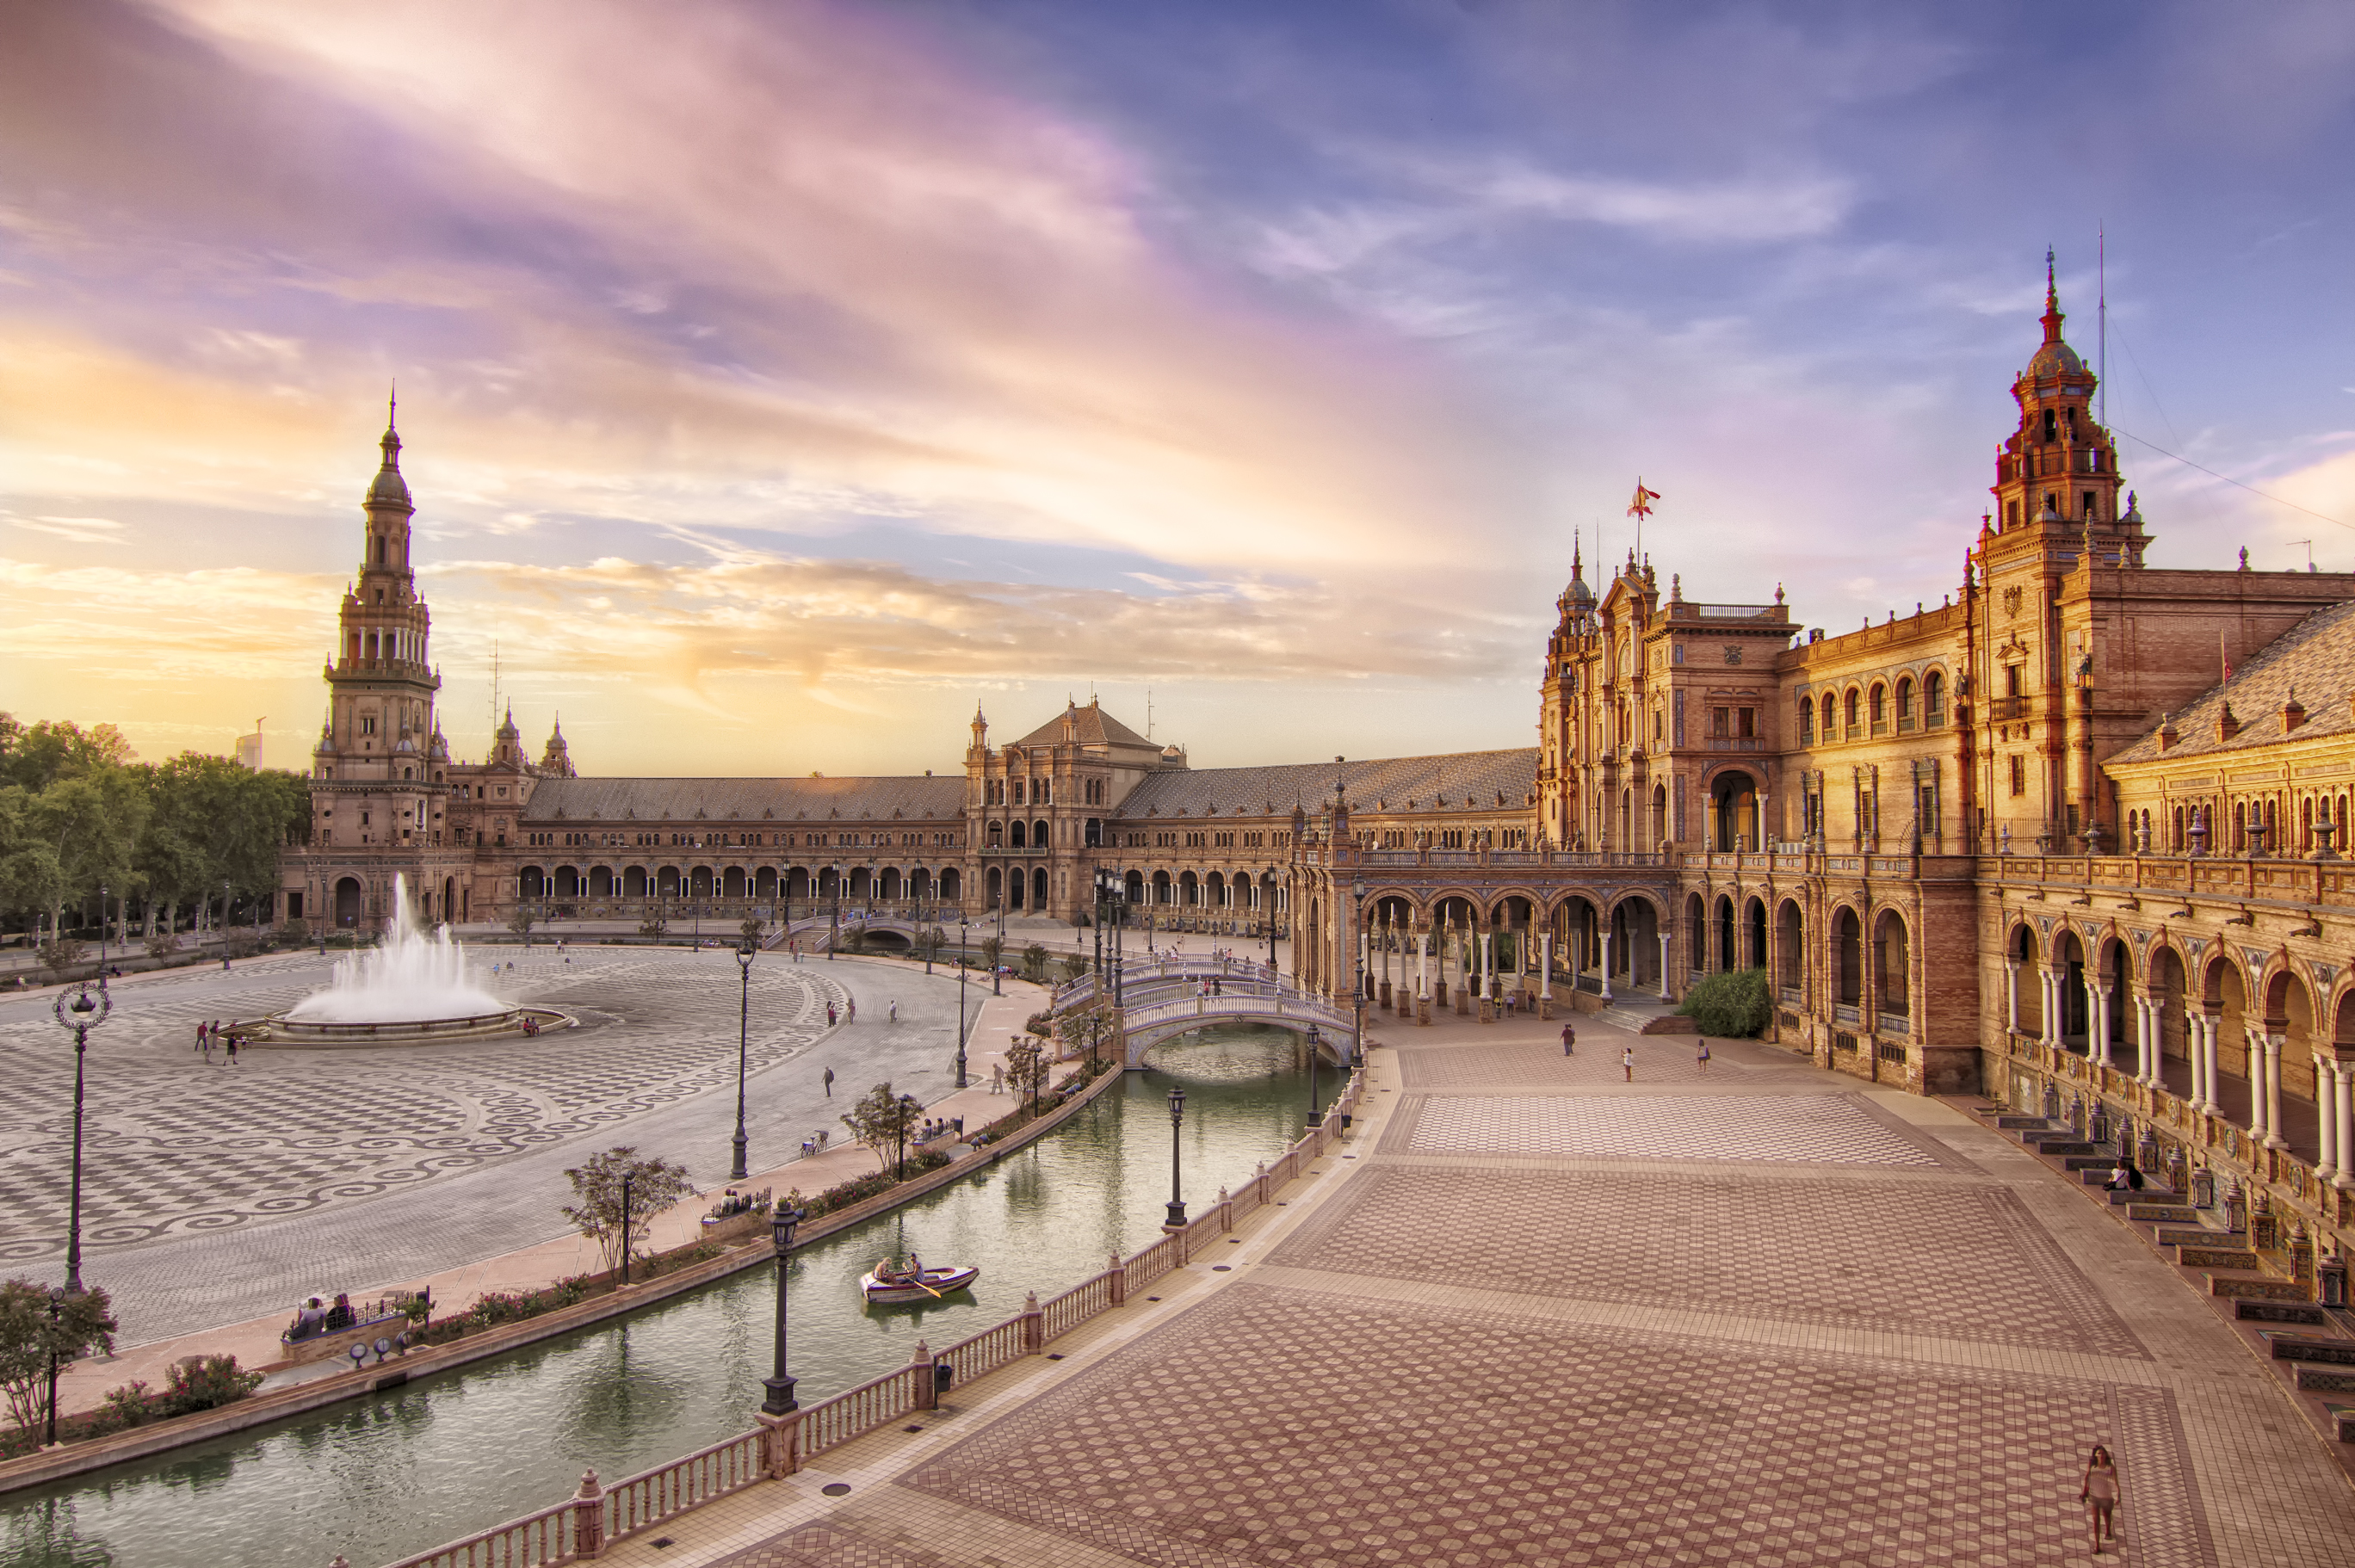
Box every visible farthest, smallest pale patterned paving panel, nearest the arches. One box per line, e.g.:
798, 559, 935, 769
1382, 1095, 1943, 1168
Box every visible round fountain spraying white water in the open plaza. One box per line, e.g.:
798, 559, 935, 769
262, 876, 572, 1046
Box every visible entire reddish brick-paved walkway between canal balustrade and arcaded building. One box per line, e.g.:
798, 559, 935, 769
584, 1007, 2355, 1568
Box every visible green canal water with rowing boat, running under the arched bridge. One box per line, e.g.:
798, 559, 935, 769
0, 1029, 1333, 1568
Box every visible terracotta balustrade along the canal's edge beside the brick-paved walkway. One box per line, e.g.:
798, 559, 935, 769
357, 1073, 1366, 1568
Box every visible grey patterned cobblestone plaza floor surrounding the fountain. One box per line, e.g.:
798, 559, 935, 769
0, 947, 974, 1344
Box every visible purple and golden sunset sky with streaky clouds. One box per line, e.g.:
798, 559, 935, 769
0, 0, 2355, 775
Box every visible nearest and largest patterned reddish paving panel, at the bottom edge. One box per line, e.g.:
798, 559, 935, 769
890, 1283, 2214, 1568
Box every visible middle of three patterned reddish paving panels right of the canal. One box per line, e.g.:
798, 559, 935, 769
1270, 1168, 2145, 1359
